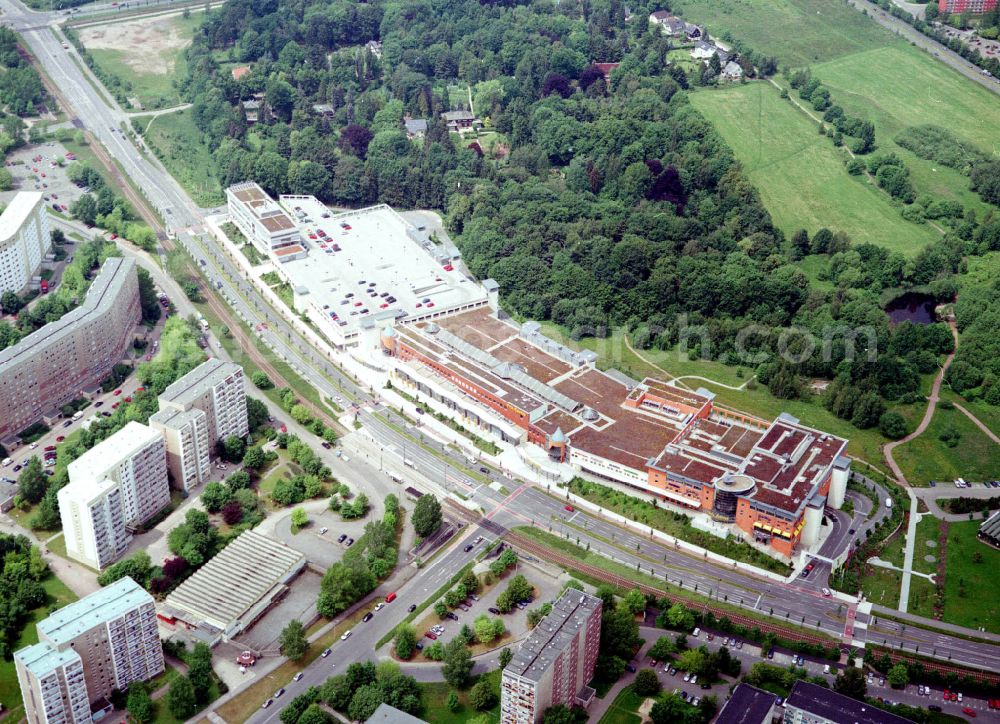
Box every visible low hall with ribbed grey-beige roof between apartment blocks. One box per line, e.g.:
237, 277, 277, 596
159, 530, 306, 643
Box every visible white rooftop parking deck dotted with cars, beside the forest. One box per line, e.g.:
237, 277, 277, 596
270, 196, 487, 336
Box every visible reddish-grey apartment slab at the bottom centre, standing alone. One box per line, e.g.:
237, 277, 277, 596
500, 589, 601, 724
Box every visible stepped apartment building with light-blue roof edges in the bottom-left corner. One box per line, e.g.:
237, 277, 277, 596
14, 578, 164, 724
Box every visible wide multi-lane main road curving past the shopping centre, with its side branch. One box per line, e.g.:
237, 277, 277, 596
0, 0, 1000, 716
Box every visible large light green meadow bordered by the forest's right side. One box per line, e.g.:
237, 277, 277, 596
690, 82, 940, 254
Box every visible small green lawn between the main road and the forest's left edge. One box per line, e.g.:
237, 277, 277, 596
145, 111, 224, 207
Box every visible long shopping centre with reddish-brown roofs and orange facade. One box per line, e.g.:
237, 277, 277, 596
381, 308, 850, 557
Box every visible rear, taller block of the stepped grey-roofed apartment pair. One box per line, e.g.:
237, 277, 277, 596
159, 359, 250, 454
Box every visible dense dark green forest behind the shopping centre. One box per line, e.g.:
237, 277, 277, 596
182, 0, 1000, 435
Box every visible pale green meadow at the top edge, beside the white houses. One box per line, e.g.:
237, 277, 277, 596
670, 0, 895, 66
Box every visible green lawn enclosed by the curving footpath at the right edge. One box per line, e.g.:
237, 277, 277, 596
894, 405, 1000, 487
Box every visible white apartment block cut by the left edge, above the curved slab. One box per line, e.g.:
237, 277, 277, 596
0, 191, 52, 293
